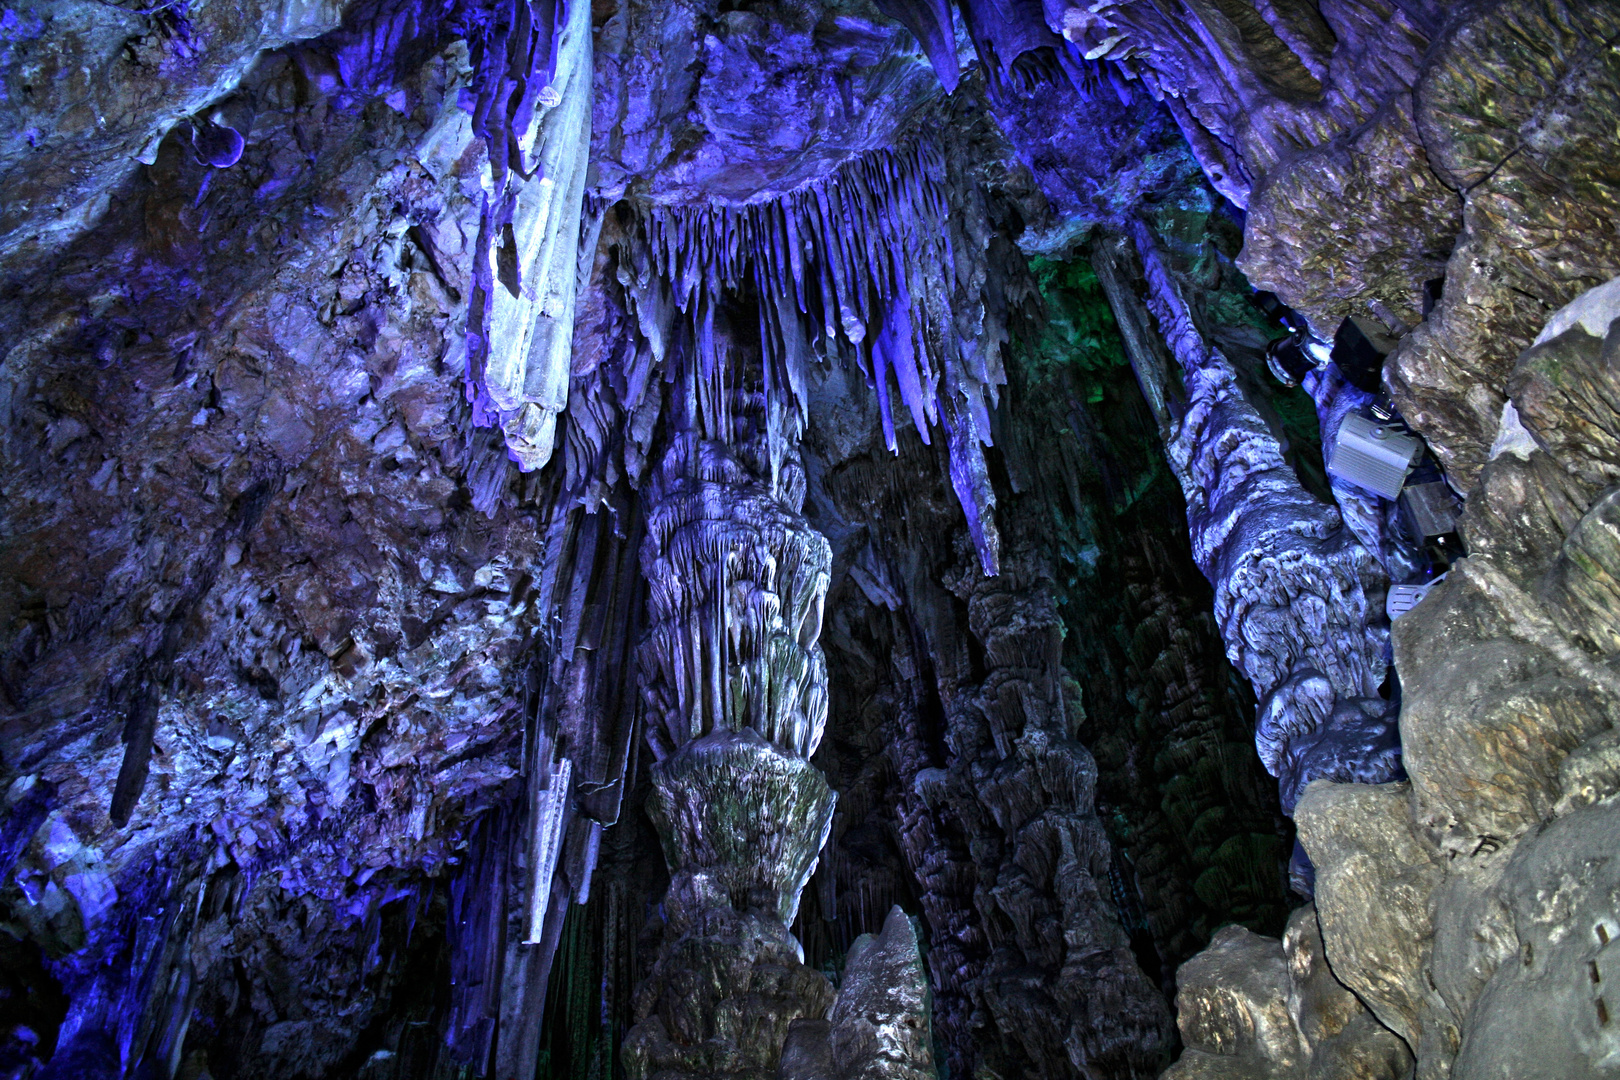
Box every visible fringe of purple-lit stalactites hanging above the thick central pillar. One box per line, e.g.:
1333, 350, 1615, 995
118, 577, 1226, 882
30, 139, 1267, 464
620, 139, 1024, 573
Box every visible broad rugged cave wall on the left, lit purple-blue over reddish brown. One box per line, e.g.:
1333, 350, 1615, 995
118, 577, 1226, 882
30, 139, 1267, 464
0, 8, 589, 1075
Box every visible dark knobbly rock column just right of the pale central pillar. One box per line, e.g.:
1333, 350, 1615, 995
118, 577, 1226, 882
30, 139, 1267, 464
810, 433, 1168, 1075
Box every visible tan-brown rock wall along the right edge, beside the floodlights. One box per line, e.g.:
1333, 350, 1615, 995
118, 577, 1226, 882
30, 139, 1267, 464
1170, 3, 1620, 1078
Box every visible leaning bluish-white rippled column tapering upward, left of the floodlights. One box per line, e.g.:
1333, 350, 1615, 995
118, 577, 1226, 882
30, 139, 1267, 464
1136, 227, 1400, 880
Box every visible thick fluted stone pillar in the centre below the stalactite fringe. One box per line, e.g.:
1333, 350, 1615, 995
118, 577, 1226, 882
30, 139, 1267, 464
624, 392, 836, 1080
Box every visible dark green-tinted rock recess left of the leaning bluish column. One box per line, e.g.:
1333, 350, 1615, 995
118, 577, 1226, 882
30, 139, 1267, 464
1003, 247, 1302, 984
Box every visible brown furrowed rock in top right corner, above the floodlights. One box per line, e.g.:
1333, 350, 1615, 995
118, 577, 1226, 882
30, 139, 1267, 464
1388, 0, 1620, 491
